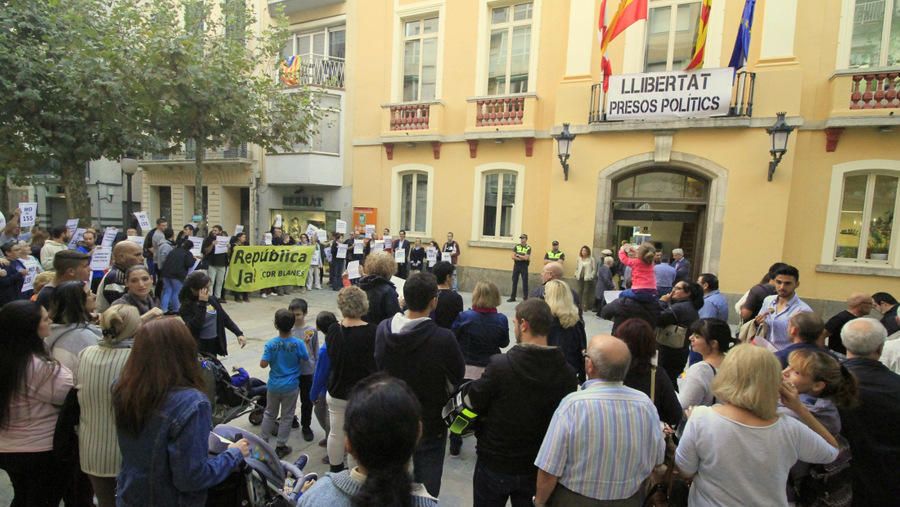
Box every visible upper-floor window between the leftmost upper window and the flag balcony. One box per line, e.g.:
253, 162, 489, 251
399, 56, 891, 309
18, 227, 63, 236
487, 2, 533, 95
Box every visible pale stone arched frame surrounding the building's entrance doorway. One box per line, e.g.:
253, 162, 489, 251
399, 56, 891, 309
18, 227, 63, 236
594, 151, 728, 273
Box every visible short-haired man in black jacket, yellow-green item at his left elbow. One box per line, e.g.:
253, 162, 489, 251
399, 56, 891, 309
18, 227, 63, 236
466, 298, 578, 507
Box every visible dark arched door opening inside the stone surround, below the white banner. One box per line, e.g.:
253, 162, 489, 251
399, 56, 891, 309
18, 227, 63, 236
609, 173, 709, 278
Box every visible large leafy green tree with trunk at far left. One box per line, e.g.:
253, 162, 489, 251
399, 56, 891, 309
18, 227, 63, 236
0, 0, 149, 226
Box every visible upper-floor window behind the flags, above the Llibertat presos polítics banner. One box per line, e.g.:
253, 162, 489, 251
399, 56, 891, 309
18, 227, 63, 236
644, 0, 700, 72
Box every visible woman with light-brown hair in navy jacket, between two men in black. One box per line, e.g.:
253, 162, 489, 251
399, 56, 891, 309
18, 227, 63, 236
445, 280, 509, 456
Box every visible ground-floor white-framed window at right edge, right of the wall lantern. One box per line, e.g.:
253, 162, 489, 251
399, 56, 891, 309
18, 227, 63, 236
833, 172, 900, 264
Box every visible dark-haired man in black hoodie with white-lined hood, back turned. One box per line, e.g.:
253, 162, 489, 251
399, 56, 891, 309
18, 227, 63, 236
375, 273, 466, 496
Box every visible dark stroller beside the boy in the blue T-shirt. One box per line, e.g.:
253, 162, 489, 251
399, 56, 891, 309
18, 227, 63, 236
200, 353, 265, 424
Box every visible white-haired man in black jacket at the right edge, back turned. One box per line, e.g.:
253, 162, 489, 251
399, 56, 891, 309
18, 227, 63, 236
840, 317, 900, 505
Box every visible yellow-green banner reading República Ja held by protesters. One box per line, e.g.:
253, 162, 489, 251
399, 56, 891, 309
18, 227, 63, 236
225, 245, 313, 292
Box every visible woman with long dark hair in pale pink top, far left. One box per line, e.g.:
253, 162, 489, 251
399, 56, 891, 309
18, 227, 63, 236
0, 300, 73, 507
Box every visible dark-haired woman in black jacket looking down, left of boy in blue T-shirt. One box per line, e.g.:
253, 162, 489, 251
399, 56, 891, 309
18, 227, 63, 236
178, 270, 247, 356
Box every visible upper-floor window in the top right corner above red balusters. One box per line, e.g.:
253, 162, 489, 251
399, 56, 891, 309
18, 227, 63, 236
850, 0, 900, 68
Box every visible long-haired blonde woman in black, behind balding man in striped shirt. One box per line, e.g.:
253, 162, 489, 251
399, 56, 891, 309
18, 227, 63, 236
544, 280, 587, 382
